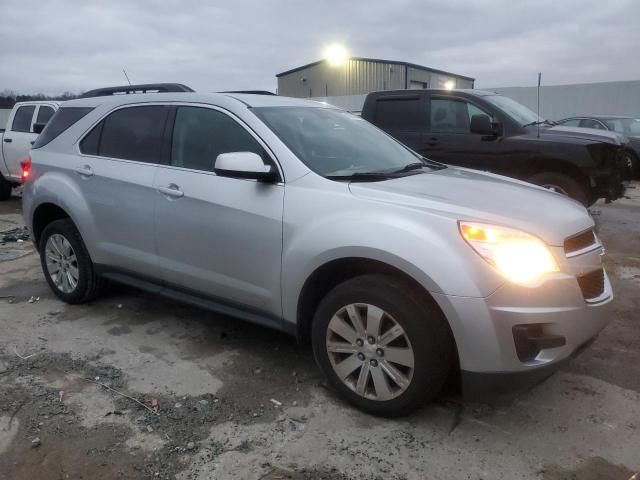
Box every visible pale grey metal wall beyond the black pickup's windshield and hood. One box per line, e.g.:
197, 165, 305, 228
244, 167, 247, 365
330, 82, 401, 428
483, 80, 640, 120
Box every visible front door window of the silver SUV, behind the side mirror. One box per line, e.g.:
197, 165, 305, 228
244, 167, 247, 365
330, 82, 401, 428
171, 107, 271, 172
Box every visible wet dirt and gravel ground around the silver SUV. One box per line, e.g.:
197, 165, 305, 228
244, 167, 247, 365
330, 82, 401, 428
0, 183, 640, 480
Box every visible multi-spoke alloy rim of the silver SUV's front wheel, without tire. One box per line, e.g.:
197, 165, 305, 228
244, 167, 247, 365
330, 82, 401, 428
326, 303, 415, 401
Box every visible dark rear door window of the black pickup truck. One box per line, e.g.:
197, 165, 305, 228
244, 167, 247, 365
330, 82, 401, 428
375, 95, 424, 132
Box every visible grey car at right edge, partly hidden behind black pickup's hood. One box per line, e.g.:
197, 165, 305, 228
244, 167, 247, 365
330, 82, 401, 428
556, 115, 640, 178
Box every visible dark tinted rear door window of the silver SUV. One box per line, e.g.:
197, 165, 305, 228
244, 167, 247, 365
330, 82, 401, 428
95, 105, 169, 163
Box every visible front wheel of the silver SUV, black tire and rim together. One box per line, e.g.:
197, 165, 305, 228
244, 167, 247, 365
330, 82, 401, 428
312, 274, 453, 417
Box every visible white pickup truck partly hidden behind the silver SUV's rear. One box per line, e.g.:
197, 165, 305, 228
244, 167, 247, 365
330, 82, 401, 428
0, 101, 60, 200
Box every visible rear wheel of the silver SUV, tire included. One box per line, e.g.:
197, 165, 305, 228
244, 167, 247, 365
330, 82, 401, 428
39, 219, 101, 303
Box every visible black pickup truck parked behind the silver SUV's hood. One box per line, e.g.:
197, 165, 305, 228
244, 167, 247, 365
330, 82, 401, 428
362, 89, 629, 205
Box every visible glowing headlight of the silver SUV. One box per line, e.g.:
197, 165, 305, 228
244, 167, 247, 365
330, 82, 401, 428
459, 222, 559, 285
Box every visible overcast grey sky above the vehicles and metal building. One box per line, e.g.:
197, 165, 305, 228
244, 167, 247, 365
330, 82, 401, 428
0, 0, 640, 94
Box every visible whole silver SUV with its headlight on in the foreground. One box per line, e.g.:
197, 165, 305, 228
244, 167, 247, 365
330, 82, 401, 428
22, 84, 613, 416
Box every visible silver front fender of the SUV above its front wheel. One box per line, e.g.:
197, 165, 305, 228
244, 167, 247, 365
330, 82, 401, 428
282, 181, 504, 322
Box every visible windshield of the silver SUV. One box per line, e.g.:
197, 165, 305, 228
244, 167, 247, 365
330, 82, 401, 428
252, 107, 427, 178
